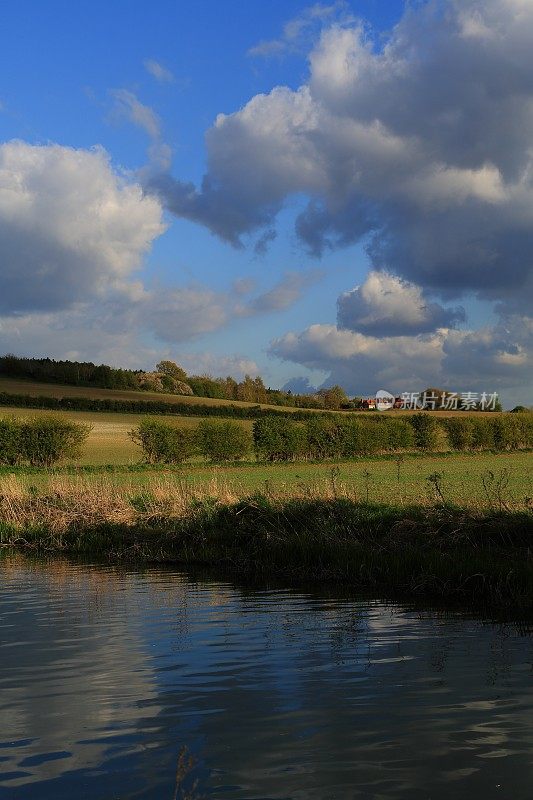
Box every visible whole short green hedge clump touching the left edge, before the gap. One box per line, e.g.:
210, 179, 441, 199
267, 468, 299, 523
0, 417, 91, 467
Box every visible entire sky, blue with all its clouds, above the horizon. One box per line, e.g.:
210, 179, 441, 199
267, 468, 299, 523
0, 0, 533, 407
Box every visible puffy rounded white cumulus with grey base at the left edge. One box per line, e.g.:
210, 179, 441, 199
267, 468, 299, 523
0, 141, 165, 313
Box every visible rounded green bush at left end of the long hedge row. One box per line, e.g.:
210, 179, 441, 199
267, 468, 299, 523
129, 419, 196, 464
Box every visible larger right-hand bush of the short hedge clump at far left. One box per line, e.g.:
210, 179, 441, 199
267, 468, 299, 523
20, 417, 91, 467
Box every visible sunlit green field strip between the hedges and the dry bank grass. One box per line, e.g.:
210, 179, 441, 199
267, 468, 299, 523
0, 450, 533, 506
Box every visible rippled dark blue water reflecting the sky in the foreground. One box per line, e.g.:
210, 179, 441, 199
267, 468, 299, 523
0, 557, 533, 800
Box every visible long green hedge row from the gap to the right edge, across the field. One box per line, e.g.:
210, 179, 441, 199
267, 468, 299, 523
131, 413, 533, 463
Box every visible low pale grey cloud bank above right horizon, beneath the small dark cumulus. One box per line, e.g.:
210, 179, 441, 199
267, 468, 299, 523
270, 316, 533, 403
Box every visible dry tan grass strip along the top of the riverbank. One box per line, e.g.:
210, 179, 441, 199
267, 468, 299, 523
0, 467, 530, 534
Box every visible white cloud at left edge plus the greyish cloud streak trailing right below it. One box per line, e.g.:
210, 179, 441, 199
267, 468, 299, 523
0, 141, 316, 363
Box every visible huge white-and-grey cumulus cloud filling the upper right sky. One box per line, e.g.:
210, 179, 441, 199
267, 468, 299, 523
145, 0, 533, 306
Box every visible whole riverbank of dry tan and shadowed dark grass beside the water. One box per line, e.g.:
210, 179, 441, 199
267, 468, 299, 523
0, 473, 533, 609
